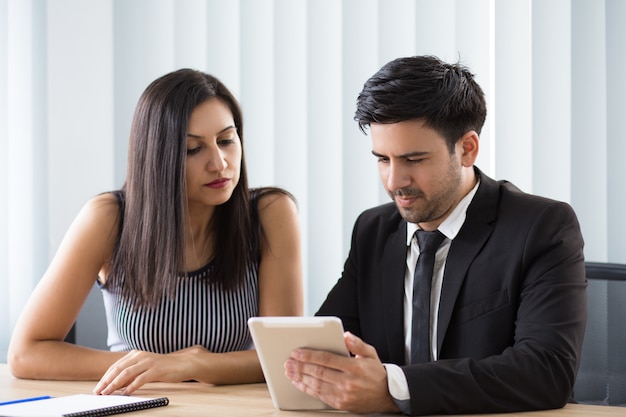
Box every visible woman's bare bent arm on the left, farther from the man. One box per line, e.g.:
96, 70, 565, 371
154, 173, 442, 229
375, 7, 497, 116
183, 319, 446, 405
8, 194, 123, 380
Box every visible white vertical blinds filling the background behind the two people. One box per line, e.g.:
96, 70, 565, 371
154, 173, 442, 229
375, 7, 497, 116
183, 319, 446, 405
0, 0, 626, 361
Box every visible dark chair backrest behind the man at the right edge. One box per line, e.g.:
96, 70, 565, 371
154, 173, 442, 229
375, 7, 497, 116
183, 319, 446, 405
574, 262, 626, 406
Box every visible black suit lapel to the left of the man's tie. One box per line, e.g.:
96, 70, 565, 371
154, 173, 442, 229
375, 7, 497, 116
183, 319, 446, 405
382, 220, 407, 364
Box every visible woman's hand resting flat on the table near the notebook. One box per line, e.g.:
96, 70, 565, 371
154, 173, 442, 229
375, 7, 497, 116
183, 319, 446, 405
94, 346, 205, 395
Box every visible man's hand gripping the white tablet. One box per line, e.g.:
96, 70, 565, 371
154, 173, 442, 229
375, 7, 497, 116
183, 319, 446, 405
285, 332, 400, 413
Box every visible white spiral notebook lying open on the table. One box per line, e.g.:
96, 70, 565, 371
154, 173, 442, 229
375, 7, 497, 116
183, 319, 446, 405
0, 394, 169, 417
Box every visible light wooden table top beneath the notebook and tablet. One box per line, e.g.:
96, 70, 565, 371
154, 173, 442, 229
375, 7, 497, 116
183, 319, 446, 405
0, 364, 626, 417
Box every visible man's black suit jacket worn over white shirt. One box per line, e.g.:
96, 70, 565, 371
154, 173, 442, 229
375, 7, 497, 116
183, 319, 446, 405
317, 168, 587, 415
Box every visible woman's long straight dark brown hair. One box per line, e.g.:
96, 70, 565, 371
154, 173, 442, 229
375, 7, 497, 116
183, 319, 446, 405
107, 69, 254, 308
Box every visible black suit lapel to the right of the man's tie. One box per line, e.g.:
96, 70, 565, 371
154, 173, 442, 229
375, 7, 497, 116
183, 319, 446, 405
437, 168, 499, 352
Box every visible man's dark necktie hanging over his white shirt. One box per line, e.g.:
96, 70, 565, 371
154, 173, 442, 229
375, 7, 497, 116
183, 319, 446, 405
411, 230, 445, 363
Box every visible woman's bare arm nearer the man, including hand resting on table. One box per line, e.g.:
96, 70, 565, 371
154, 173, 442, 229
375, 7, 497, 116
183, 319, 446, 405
94, 193, 303, 394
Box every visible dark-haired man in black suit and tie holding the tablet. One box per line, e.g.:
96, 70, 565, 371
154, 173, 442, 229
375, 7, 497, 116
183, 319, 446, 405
285, 56, 586, 415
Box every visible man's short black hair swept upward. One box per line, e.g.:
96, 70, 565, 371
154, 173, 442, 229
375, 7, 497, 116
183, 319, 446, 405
354, 56, 487, 152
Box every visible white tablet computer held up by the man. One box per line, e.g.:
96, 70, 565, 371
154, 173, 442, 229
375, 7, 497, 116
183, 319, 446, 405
248, 317, 349, 410
